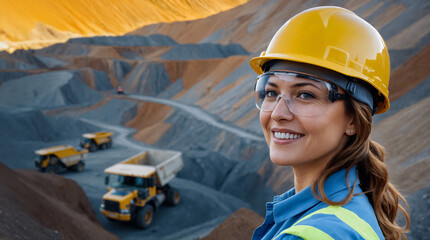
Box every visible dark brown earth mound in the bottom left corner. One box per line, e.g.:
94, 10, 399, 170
0, 163, 118, 240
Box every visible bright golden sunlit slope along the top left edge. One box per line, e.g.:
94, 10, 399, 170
0, 0, 246, 52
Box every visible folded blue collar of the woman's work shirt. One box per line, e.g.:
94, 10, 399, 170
273, 166, 361, 223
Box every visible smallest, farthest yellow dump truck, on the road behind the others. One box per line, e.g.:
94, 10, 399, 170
79, 131, 113, 152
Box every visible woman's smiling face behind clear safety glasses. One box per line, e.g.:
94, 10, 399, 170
260, 72, 355, 169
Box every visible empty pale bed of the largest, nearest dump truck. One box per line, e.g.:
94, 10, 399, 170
105, 149, 183, 186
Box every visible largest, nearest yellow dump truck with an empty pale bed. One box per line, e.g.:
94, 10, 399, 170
100, 150, 183, 229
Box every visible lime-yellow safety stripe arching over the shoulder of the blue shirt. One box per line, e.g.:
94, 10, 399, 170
278, 206, 379, 240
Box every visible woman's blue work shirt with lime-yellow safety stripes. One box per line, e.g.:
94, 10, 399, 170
252, 167, 384, 240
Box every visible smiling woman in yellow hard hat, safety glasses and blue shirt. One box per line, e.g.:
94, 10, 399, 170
250, 7, 409, 240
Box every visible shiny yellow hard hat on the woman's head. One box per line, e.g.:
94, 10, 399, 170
249, 6, 390, 113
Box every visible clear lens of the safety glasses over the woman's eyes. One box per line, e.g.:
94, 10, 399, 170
255, 72, 331, 117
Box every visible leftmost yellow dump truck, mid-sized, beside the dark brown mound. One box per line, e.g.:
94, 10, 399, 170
35, 145, 88, 173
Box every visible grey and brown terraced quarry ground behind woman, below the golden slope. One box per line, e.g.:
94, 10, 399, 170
0, 0, 430, 240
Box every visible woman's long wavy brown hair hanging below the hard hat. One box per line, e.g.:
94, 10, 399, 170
312, 99, 410, 239
